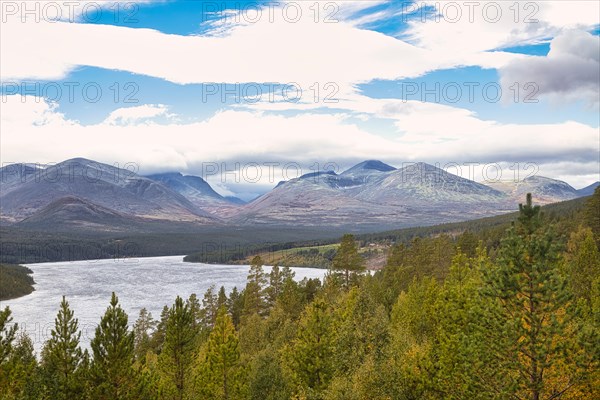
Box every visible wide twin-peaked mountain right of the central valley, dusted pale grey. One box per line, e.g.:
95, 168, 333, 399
233, 161, 516, 227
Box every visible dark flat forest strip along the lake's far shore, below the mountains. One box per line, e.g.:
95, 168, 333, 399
0, 226, 342, 264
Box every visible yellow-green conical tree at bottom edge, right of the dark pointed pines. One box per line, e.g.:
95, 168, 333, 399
199, 307, 243, 400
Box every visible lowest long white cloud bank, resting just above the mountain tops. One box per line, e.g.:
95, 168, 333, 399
0, 95, 600, 188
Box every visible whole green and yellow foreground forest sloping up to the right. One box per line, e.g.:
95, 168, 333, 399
0, 189, 600, 400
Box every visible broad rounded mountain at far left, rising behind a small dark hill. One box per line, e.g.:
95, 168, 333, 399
0, 158, 218, 228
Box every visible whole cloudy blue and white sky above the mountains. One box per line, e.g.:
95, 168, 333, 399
0, 0, 600, 199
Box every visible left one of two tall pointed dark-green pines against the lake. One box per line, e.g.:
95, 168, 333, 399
42, 296, 83, 400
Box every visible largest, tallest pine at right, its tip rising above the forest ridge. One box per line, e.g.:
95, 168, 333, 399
483, 194, 573, 400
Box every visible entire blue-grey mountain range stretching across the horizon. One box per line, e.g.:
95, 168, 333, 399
0, 158, 599, 231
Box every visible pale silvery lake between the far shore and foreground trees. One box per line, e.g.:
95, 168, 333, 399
0, 256, 326, 354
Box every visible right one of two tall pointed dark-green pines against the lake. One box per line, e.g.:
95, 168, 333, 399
90, 292, 137, 400
